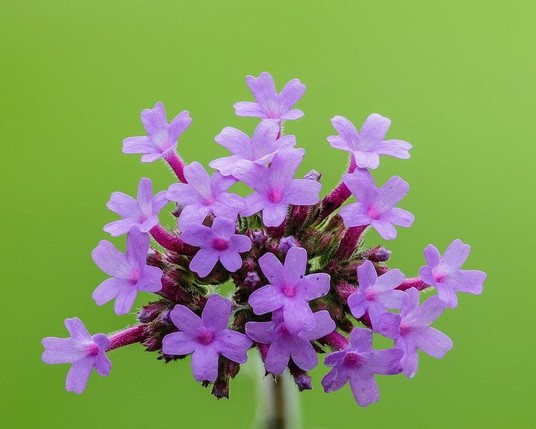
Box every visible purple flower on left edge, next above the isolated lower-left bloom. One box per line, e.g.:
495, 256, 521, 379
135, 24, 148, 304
91, 228, 162, 314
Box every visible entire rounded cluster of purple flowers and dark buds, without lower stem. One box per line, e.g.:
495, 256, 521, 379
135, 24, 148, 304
42, 73, 486, 406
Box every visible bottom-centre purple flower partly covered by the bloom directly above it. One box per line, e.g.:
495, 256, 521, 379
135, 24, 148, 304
246, 310, 335, 375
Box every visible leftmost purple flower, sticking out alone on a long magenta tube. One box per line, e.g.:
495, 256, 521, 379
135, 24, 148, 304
41, 317, 112, 394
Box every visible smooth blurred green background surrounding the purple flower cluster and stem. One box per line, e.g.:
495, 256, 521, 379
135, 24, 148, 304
0, 0, 536, 429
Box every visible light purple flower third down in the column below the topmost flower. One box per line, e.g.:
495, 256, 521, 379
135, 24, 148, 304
234, 149, 322, 226
